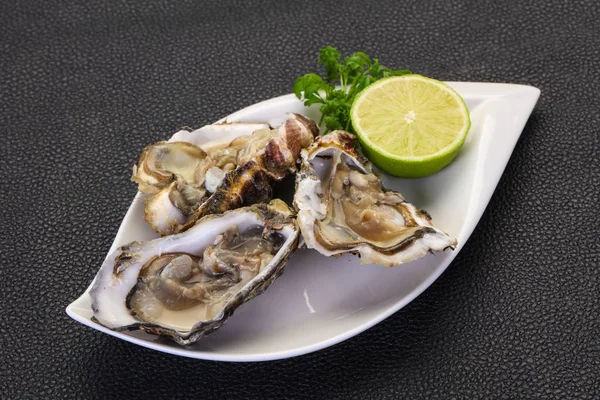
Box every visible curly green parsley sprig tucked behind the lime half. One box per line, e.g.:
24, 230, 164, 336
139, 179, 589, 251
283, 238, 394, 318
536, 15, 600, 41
294, 46, 412, 133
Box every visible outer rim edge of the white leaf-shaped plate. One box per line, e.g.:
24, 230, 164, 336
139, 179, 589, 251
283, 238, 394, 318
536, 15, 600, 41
65, 81, 541, 362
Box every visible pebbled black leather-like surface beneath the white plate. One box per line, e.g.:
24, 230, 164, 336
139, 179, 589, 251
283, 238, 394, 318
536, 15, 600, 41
0, 0, 600, 399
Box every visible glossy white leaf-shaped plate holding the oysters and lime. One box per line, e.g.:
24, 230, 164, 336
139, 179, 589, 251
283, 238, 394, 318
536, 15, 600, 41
66, 82, 540, 361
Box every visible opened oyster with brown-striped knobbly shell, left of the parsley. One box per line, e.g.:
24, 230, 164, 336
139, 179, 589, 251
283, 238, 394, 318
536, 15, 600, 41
132, 114, 317, 235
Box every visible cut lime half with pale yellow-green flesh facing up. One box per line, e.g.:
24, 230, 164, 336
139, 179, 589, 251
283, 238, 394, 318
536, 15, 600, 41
351, 75, 471, 178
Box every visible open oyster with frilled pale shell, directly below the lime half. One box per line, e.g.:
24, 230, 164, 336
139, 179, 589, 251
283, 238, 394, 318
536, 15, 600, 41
294, 131, 456, 267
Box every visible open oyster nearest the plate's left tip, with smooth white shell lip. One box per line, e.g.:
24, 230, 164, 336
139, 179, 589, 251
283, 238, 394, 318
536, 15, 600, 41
90, 200, 299, 345
